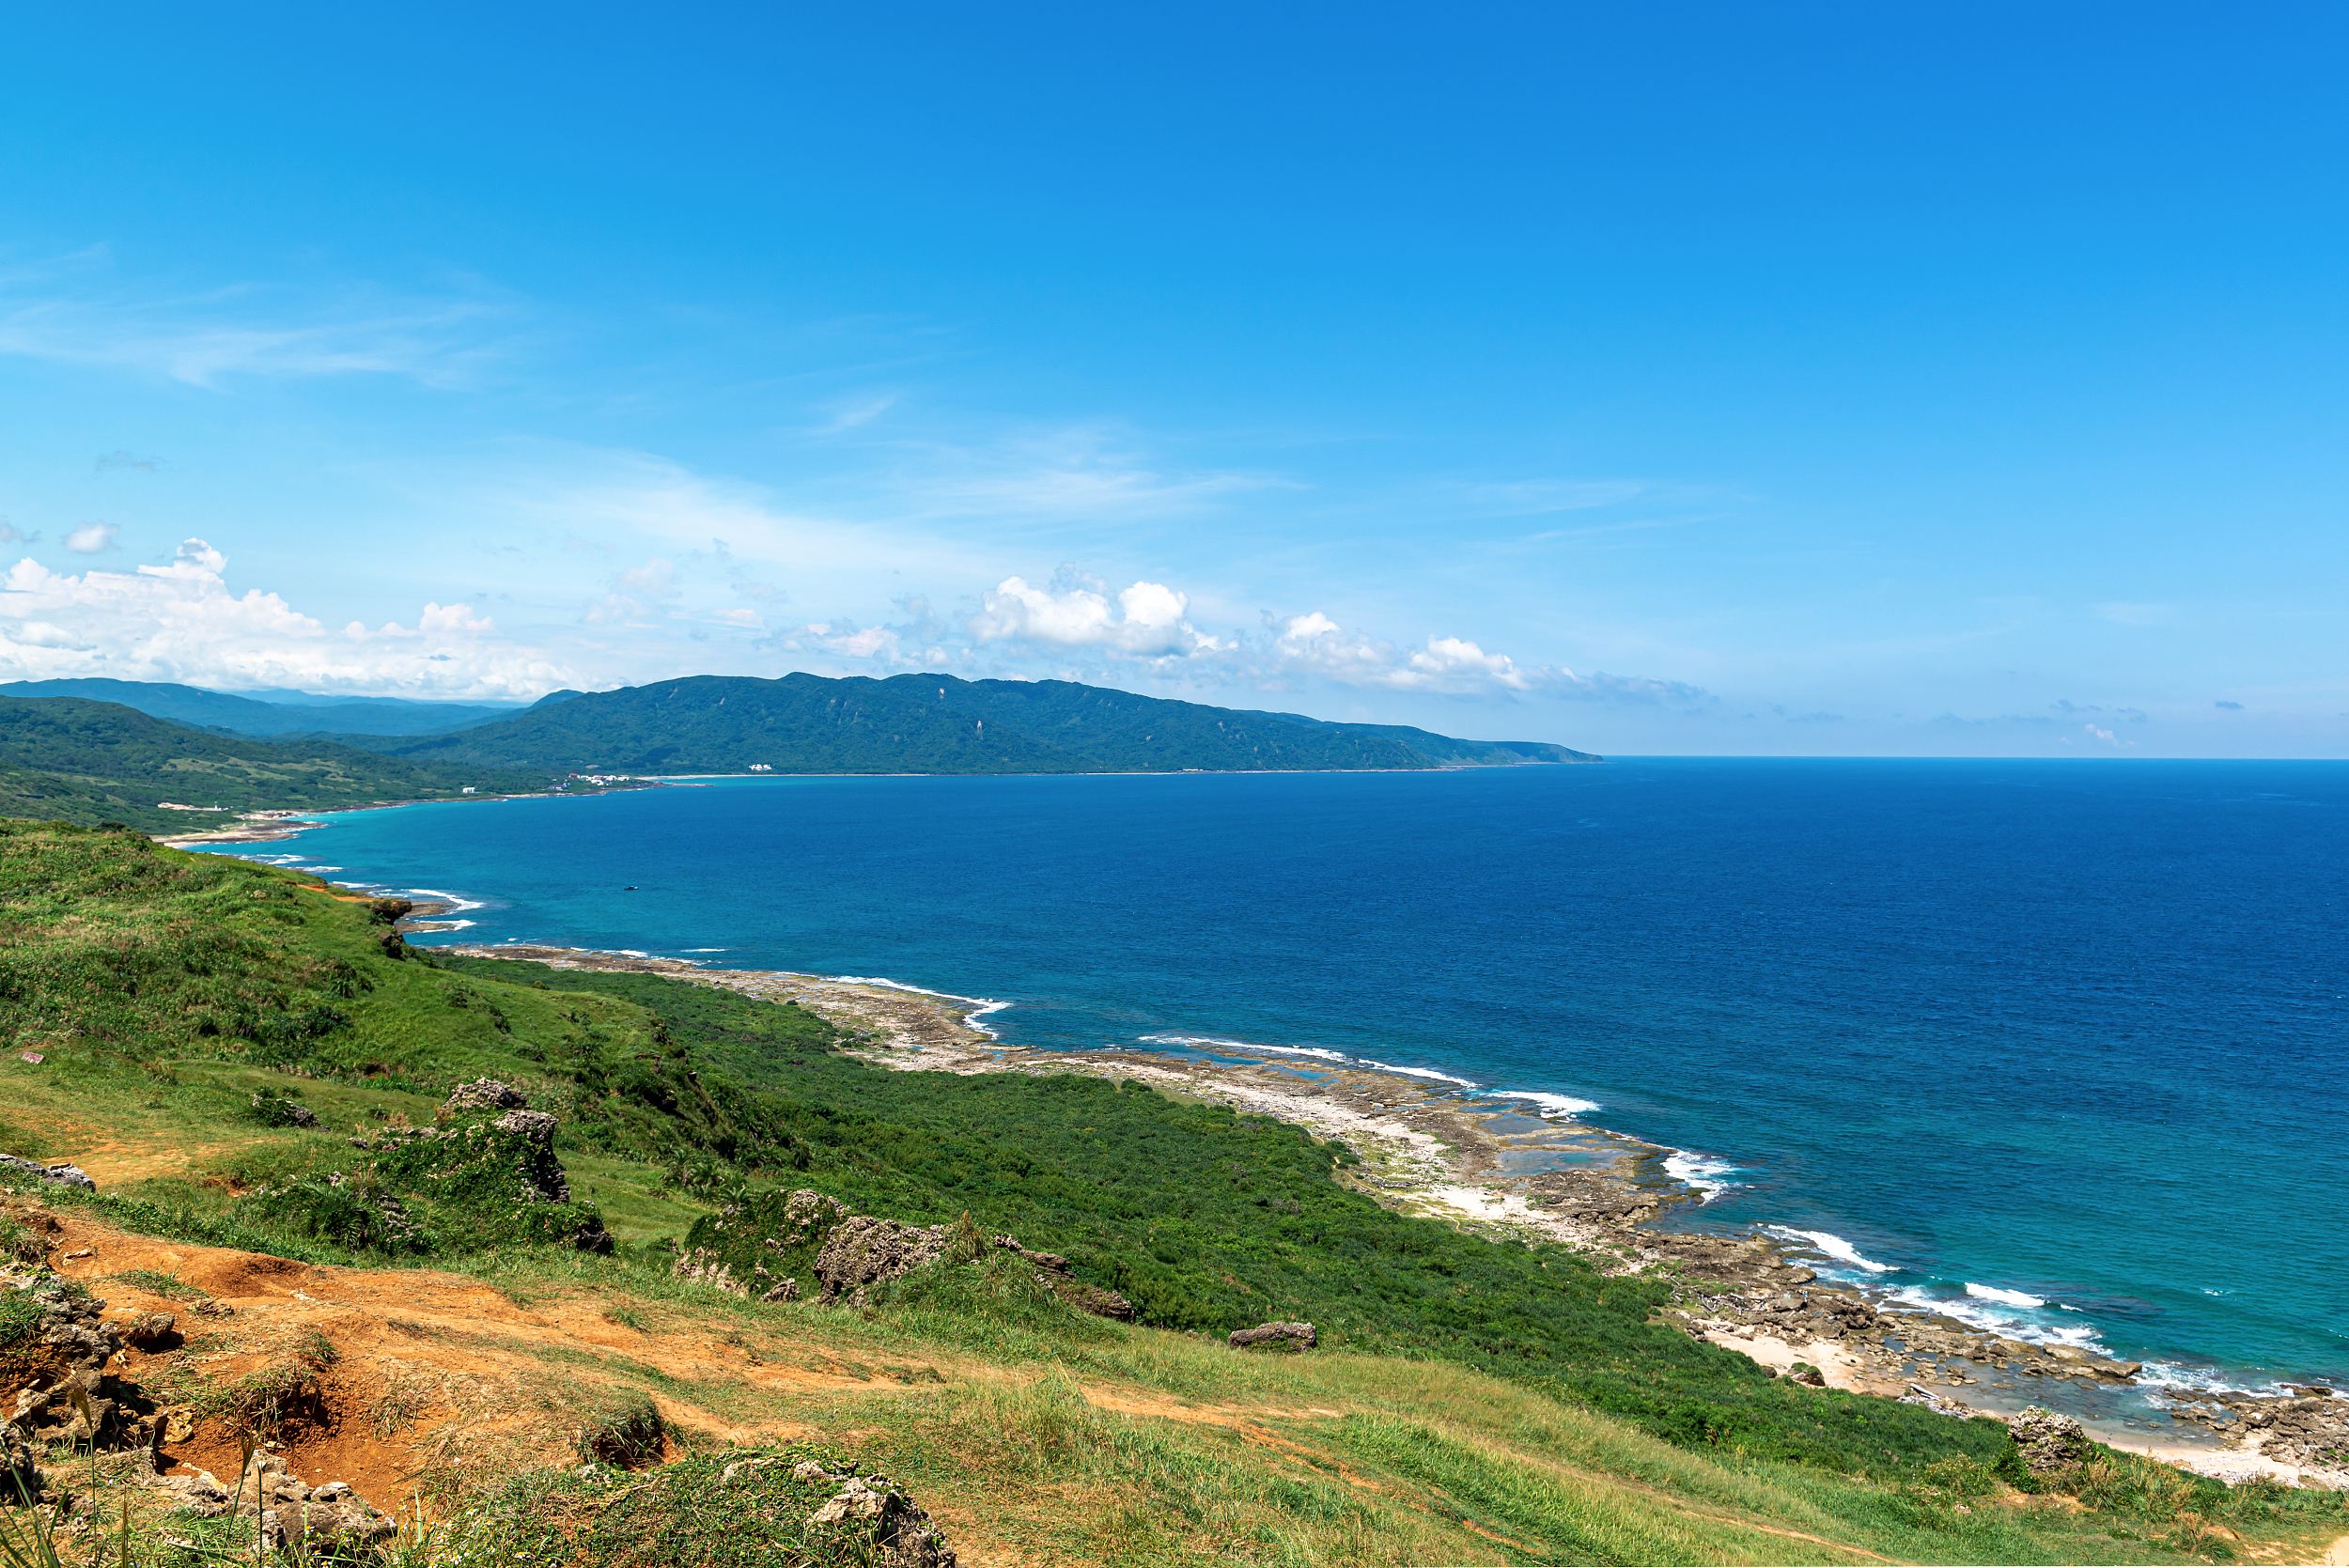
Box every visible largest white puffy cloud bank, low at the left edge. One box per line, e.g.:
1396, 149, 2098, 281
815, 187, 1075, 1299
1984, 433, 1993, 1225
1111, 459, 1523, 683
0, 540, 571, 697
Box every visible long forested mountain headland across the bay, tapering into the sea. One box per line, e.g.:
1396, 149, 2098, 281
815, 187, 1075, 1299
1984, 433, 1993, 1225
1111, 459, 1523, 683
385, 674, 1595, 772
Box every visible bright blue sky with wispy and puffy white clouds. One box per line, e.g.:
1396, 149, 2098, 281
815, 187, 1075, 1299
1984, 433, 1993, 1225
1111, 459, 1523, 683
0, 5, 2349, 756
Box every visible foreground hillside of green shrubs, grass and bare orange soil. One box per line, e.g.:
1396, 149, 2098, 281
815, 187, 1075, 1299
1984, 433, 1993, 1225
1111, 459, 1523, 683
0, 824, 2349, 1563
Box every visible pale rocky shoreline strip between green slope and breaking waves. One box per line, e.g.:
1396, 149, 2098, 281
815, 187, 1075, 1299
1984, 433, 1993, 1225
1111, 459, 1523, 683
443, 927, 2349, 1488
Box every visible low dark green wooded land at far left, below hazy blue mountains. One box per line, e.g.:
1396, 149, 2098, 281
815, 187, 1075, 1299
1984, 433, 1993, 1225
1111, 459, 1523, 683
0, 697, 548, 833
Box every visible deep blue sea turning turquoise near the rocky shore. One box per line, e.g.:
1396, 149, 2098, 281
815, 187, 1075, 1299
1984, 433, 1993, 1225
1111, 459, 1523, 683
233, 761, 2349, 1383
